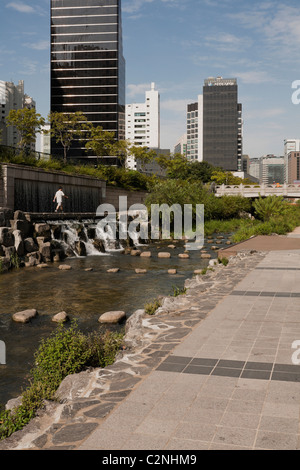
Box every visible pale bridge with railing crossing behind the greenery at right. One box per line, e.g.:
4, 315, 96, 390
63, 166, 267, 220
215, 183, 300, 197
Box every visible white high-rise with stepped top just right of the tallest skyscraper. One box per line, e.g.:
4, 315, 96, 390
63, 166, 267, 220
125, 82, 160, 168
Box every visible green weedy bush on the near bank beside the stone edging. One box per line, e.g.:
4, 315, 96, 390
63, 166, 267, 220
0, 321, 124, 440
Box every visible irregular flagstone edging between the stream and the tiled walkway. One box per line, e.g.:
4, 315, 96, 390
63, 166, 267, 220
0, 250, 266, 450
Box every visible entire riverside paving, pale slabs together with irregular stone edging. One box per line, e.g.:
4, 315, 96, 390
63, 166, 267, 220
0, 230, 300, 452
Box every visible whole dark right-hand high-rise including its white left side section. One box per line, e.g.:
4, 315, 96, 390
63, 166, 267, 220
187, 77, 243, 171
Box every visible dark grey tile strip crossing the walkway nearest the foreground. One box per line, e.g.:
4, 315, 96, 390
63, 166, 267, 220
156, 356, 300, 382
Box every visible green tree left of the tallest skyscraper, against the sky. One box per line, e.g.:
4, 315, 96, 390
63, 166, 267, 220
6, 108, 45, 150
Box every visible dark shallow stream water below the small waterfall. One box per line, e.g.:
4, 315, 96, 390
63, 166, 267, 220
0, 239, 227, 404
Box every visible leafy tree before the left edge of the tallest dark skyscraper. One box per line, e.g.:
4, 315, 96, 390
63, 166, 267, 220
48, 111, 90, 163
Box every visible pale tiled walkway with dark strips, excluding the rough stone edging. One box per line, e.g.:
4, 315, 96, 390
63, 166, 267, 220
79, 241, 300, 450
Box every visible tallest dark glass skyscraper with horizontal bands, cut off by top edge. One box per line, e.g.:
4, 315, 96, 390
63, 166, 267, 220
51, 0, 125, 159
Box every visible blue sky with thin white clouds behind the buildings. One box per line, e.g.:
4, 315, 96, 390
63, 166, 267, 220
0, 0, 300, 158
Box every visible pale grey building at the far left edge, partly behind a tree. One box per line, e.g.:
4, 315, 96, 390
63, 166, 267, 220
0, 80, 36, 150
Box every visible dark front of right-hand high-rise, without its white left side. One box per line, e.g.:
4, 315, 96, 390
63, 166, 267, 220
203, 77, 242, 171
